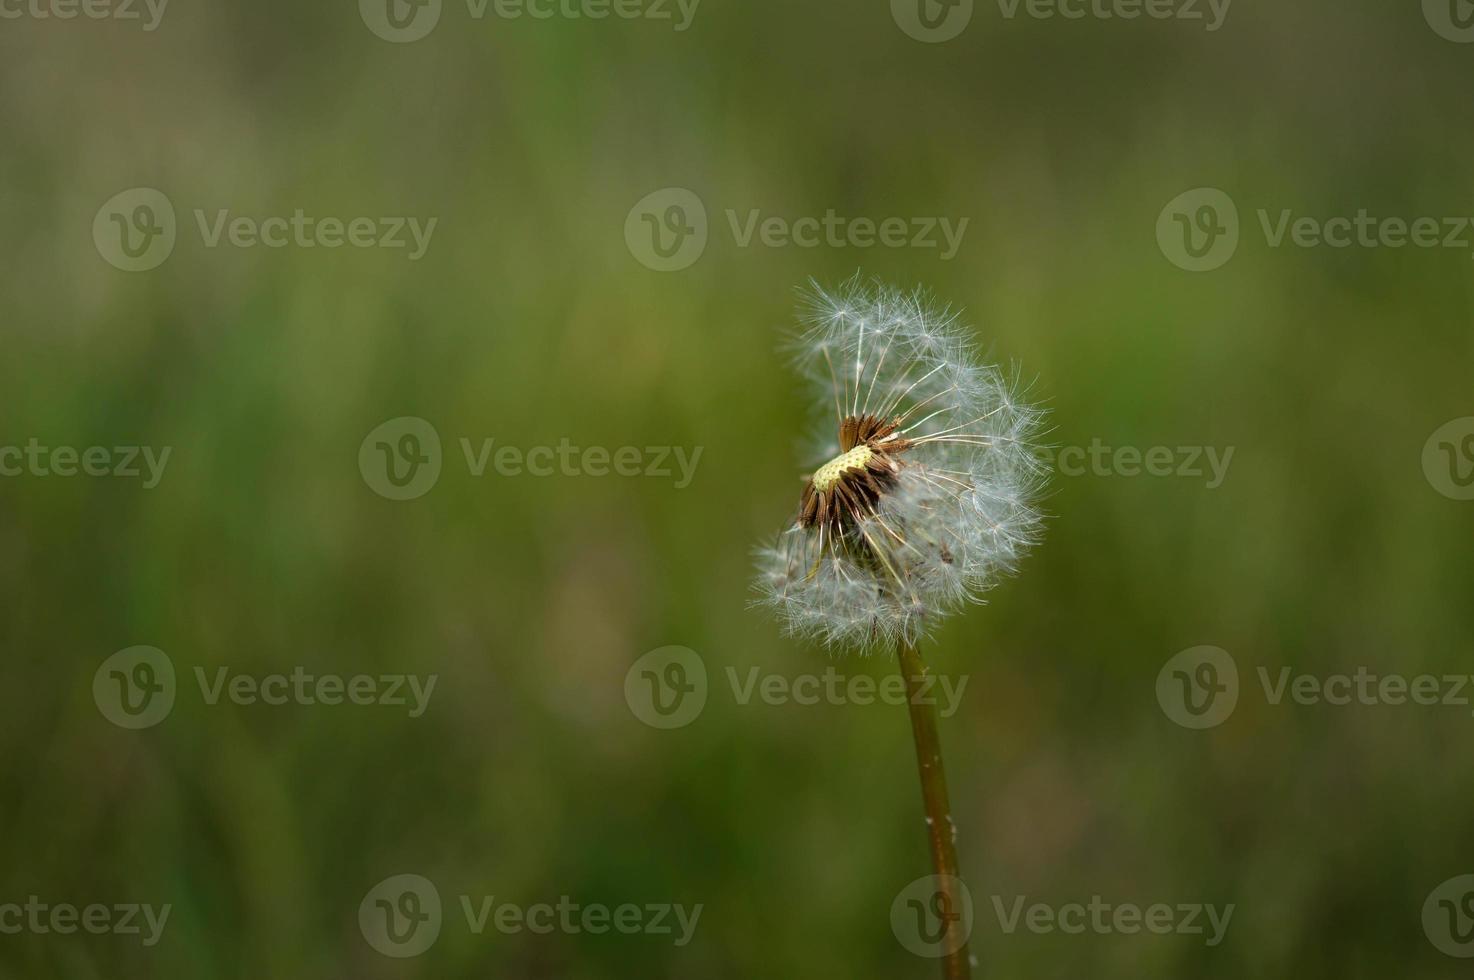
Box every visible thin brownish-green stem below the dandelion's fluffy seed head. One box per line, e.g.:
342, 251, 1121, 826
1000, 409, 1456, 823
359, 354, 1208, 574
899, 640, 971, 980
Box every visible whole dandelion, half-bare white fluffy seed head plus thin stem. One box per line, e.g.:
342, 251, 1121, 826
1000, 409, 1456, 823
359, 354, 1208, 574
755, 277, 1044, 977
